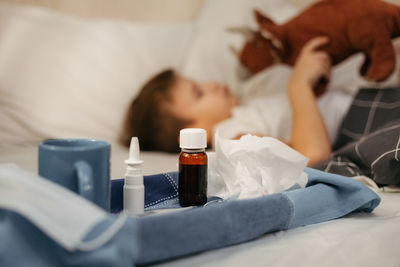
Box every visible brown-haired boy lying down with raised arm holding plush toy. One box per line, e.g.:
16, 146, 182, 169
120, 37, 331, 165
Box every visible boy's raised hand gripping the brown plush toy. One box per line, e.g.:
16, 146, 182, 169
290, 37, 331, 88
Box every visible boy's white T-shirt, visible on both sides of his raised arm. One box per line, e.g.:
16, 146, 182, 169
214, 91, 352, 143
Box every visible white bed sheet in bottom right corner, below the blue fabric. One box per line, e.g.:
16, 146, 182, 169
156, 193, 400, 267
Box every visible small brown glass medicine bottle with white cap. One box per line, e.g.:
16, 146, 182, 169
179, 128, 207, 207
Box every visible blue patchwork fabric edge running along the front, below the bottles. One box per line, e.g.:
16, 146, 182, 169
0, 169, 380, 266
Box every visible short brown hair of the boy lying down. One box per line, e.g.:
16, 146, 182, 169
120, 69, 190, 153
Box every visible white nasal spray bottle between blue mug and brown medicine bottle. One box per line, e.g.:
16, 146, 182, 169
124, 137, 144, 215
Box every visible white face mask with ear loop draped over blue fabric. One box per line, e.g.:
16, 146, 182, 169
0, 164, 126, 251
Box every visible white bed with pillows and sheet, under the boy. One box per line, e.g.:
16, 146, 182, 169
0, 0, 400, 266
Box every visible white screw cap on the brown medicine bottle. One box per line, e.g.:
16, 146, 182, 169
179, 128, 207, 149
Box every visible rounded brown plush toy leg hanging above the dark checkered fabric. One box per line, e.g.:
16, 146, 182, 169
360, 37, 396, 82
